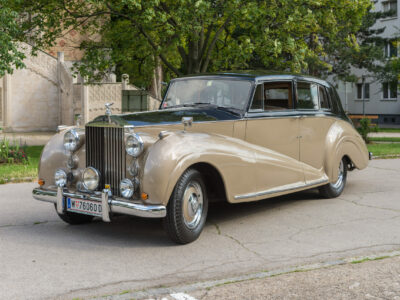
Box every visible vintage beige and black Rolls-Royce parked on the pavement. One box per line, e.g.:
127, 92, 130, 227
33, 72, 369, 244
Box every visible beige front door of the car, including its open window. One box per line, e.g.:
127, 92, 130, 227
245, 80, 304, 194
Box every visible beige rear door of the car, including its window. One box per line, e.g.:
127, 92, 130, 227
297, 81, 335, 184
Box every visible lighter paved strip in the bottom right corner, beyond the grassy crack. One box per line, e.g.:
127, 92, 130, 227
155, 257, 400, 300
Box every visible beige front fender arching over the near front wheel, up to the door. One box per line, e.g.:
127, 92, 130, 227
142, 131, 257, 205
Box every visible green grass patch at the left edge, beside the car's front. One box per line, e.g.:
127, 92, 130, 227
0, 146, 43, 184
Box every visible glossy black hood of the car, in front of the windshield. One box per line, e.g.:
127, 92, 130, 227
88, 107, 240, 127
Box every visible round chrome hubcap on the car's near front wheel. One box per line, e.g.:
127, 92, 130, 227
183, 181, 203, 229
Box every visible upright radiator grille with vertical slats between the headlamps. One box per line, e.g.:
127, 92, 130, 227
86, 126, 125, 196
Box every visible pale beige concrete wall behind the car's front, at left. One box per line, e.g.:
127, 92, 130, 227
0, 44, 160, 132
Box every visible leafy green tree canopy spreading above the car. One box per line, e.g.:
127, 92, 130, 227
0, 0, 370, 87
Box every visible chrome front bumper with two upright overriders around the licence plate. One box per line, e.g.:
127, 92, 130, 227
32, 188, 166, 222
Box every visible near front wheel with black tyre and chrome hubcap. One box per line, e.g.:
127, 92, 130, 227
164, 169, 208, 244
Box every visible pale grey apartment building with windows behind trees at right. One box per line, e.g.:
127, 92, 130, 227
337, 0, 400, 127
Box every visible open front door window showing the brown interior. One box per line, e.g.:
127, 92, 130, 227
264, 82, 293, 110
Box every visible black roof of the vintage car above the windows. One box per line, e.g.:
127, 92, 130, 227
173, 70, 330, 86
